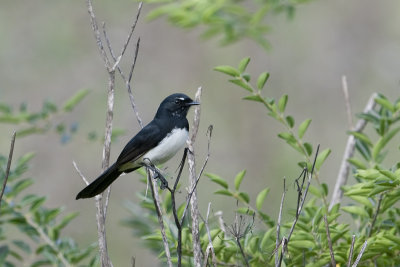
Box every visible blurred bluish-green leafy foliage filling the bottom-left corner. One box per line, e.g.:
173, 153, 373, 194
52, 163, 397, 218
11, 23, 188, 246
0, 153, 97, 267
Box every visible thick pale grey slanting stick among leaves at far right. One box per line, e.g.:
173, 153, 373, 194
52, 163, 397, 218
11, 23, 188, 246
329, 93, 378, 210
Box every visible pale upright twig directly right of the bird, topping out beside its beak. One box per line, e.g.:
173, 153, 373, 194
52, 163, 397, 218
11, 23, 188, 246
187, 87, 202, 267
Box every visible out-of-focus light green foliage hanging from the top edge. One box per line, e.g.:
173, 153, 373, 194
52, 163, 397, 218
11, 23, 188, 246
141, 0, 309, 49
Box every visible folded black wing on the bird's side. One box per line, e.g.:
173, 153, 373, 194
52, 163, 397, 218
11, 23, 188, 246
116, 120, 163, 166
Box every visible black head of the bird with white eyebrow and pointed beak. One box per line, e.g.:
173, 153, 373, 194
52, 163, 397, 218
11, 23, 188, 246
156, 93, 200, 117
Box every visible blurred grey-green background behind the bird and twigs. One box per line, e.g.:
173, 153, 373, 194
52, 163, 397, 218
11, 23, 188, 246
0, 0, 400, 266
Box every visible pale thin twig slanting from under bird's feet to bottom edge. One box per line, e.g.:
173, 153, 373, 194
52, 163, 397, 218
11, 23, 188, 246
147, 170, 173, 267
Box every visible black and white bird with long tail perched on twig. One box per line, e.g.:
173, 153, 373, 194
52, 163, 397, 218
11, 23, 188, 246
76, 93, 200, 199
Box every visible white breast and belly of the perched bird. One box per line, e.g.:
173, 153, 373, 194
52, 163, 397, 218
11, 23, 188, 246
143, 128, 189, 165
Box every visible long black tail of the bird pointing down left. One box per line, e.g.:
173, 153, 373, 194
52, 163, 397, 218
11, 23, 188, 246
76, 163, 122, 199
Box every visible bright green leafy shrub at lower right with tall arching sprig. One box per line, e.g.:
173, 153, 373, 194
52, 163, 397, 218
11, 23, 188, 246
125, 58, 400, 266
